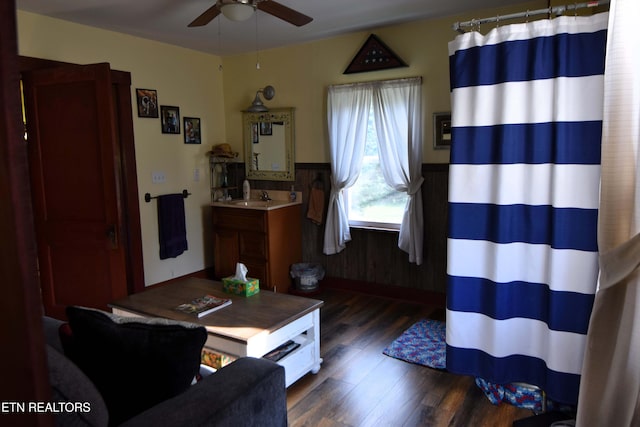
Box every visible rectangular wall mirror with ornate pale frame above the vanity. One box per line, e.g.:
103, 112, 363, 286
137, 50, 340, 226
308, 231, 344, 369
243, 108, 295, 181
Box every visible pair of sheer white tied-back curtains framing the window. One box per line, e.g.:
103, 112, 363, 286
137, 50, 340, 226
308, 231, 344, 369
324, 77, 423, 264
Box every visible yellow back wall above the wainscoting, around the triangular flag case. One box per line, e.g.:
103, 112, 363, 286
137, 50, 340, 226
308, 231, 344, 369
223, 1, 546, 163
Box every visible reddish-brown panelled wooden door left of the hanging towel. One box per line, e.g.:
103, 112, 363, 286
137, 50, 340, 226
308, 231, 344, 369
23, 64, 127, 318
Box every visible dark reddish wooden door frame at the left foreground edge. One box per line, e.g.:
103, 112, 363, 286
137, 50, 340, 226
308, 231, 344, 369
0, 1, 53, 427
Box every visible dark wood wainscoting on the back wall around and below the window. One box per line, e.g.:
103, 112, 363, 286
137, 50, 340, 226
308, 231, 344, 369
246, 163, 449, 293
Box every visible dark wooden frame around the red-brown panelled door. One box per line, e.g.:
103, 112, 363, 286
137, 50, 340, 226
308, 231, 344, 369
18, 56, 145, 294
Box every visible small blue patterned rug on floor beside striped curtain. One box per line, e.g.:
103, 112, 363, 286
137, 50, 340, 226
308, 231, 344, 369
382, 319, 447, 369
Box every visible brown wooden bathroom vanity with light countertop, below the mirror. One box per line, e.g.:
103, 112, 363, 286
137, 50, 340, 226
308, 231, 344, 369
212, 190, 302, 293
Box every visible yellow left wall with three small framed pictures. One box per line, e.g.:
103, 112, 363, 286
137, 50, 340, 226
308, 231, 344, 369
18, 11, 225, 285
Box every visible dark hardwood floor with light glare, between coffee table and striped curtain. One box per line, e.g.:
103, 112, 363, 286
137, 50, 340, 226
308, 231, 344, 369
287, 289, 533, 427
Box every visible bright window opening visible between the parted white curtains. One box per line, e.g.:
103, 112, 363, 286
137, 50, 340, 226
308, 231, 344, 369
345, 109, 409, 230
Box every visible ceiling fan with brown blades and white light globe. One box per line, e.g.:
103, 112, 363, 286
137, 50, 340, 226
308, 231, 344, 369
188, 0, 313, 27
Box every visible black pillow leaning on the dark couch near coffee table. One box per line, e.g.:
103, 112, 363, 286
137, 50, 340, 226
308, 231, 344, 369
63, 307, 207, 425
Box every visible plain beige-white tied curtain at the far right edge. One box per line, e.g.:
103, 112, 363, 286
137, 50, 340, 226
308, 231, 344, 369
577, 0, 640, 427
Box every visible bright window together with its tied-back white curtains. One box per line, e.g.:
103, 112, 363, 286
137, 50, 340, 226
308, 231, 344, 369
323, 77, 424, 265
